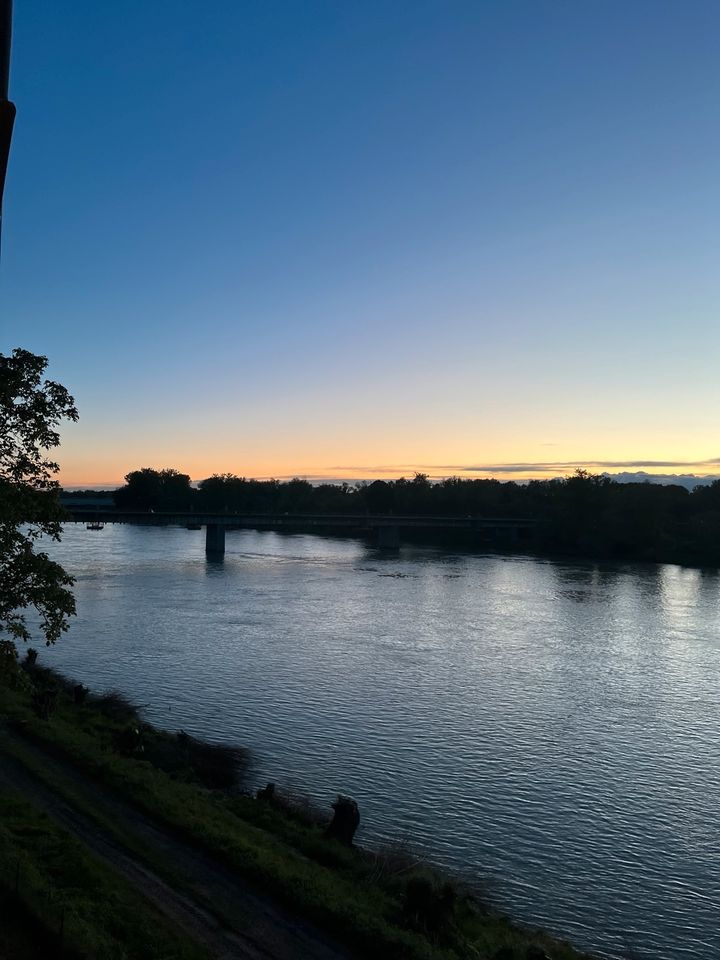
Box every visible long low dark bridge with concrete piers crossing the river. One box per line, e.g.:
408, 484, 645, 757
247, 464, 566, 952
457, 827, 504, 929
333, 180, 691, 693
68, 506, 540, 556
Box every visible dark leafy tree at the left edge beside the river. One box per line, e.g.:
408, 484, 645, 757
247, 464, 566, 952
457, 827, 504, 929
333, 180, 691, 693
0, 350, 78, 644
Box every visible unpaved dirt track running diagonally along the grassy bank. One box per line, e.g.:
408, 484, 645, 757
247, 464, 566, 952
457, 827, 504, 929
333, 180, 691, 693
0, 729, 351, 960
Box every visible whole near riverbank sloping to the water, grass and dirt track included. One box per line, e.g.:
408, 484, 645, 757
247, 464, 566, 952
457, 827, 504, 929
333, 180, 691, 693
0, 652, 583, 960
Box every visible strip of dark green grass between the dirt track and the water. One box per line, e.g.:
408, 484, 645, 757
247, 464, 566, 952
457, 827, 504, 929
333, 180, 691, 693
0, 648, 582, 960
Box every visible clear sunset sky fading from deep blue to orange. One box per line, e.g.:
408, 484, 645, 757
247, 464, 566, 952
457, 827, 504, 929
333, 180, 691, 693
0, 0, 720, 486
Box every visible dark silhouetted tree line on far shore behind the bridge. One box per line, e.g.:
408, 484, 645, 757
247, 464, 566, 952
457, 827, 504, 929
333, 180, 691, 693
108, 467, 720, 565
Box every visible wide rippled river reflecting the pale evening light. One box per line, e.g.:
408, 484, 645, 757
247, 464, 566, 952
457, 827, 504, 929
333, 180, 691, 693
36, 526, 720, 960
